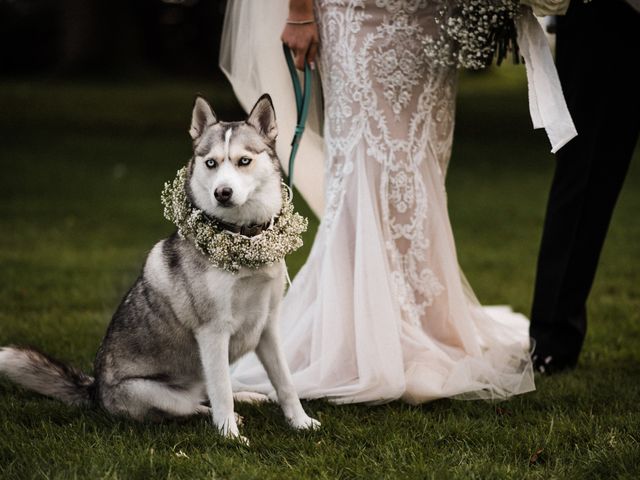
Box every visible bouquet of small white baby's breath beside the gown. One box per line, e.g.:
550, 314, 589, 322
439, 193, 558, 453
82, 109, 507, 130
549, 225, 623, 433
424, 0, 569, 70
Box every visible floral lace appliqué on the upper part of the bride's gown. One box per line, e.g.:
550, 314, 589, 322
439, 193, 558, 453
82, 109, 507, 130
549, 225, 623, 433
319, 0, 455, 324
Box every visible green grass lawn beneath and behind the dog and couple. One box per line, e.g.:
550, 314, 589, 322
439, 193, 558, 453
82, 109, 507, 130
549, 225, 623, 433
0, 68, 640, 479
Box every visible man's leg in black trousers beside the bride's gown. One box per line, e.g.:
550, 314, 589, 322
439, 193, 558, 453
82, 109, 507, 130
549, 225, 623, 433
531, 0, 640, 367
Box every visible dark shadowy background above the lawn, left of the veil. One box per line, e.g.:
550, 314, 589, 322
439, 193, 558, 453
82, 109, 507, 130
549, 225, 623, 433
0, 0, 226, 77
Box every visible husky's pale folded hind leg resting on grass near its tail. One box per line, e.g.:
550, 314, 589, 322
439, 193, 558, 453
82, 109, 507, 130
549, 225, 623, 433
102, 378, 206, 420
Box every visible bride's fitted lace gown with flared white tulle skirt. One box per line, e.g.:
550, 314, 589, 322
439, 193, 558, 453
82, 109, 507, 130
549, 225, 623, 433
222, 0, 534, 403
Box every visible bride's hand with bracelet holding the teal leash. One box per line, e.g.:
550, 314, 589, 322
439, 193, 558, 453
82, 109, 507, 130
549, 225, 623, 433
280, 0, 319, 70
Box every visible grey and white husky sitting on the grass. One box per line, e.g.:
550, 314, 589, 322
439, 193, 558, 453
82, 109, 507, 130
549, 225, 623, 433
0, 95, 320, 441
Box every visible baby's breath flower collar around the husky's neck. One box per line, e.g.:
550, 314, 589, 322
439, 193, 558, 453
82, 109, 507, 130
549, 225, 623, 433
161, 167, 308, 273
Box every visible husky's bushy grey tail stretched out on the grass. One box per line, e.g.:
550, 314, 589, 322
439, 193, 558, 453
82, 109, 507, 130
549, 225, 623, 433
0, 346, 94, 405
